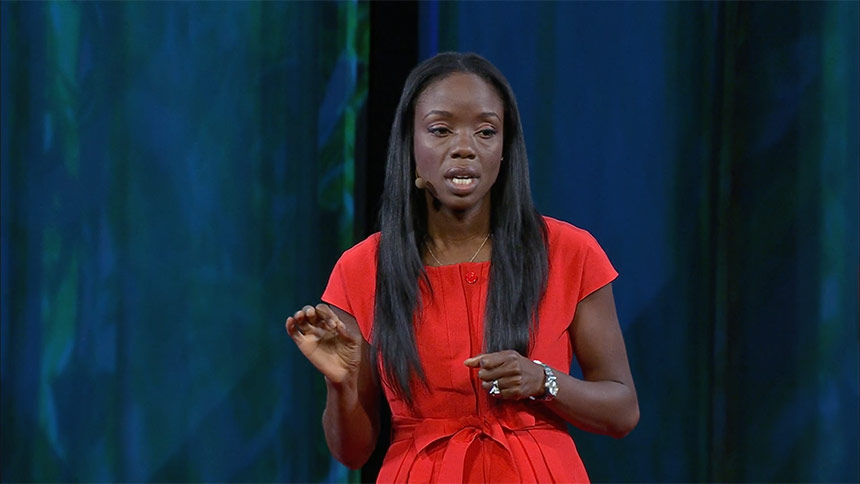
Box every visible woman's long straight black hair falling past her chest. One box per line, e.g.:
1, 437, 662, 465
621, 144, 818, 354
372, 52, 549, 402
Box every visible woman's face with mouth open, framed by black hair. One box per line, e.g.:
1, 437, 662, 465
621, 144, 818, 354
412, 73, 504, 211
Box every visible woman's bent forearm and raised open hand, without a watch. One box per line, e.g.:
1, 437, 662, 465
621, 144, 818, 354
287, 304, 379, 469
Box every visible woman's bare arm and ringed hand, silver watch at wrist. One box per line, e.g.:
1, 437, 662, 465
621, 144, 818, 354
465, 284, 639, 438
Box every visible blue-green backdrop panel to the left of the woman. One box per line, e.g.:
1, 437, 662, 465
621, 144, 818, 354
0, 2, 369, 482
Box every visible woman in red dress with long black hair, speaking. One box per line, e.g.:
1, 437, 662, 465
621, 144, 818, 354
286, 53, 639, 482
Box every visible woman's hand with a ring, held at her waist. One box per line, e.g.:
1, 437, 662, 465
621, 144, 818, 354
463, 350, 546, 400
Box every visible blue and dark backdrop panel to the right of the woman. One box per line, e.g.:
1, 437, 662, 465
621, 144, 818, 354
420, 2, 860, 482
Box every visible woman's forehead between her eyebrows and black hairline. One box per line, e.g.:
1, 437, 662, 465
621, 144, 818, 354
415, 72, 504, 117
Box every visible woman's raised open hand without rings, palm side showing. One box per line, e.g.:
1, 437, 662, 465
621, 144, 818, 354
286, 304, 362, 384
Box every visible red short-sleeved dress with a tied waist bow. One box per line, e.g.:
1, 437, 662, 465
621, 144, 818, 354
322, 217, 618, 483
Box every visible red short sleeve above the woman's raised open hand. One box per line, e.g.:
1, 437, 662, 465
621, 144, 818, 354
321, 234, 379, 341
